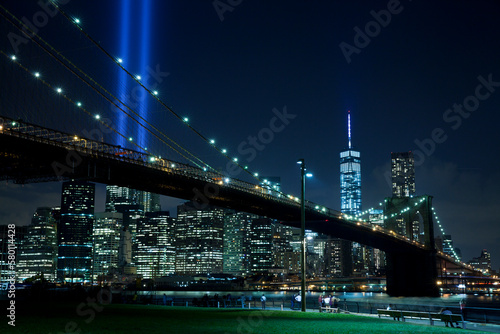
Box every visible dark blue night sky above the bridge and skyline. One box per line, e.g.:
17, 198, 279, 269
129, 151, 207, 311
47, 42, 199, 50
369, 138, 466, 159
0, 0, 500, 270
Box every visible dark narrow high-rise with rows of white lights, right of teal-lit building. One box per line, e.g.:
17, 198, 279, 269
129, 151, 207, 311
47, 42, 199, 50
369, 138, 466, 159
250, 218, 274, 273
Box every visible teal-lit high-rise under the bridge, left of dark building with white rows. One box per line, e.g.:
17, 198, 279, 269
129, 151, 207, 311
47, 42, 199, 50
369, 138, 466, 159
223, 210, 258, 276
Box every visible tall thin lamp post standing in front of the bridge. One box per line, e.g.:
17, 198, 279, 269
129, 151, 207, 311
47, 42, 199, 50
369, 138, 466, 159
297, 159, 312, 312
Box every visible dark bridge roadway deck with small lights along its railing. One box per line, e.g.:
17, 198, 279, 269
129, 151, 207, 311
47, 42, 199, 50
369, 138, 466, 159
0, 117, 476, 295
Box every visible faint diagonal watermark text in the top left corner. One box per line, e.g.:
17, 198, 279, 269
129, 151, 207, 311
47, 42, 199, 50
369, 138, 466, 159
7, 0, 70, 53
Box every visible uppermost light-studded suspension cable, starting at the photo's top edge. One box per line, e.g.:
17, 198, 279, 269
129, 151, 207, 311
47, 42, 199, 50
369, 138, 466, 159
54, 3, 260, 182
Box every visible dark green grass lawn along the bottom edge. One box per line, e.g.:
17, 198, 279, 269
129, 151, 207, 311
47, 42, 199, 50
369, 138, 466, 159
0, 303, 479, 334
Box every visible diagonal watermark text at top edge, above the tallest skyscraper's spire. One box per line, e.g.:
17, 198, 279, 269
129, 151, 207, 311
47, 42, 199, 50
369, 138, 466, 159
339, 0, 411, 64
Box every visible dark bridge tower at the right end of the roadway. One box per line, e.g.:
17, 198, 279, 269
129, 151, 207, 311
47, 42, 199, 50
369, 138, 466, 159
384, 195, 439, 296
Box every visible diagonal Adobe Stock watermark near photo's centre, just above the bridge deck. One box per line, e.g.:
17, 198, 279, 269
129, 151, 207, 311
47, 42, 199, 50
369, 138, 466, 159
192, 106, 297, 210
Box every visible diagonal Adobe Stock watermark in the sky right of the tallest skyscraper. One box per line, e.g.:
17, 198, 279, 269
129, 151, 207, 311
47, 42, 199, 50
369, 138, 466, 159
386, 73, 500, 184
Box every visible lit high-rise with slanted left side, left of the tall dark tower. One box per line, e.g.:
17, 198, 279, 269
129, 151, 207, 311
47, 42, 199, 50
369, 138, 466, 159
16, 207, 57, 282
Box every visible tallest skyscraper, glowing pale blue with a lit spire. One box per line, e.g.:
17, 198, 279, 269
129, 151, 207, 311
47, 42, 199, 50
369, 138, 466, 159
338, 111, 364, 276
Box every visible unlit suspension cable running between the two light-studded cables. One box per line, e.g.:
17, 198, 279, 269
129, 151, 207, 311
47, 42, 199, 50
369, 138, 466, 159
0, 5, 214, 170
